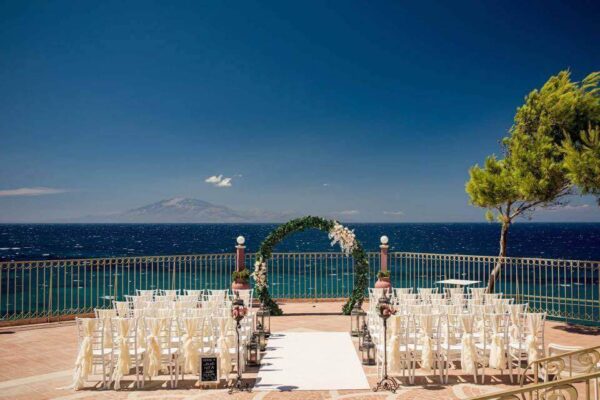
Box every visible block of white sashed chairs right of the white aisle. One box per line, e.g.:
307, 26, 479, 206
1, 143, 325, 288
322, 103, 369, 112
367, 291, 546, 382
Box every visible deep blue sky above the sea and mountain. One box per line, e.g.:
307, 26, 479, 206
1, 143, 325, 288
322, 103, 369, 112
0, 1, 600, 222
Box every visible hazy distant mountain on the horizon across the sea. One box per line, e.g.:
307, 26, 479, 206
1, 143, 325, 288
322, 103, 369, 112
77, 197, 292, 223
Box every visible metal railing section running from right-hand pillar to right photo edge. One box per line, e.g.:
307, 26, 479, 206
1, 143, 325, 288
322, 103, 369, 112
388, 253, 600, 325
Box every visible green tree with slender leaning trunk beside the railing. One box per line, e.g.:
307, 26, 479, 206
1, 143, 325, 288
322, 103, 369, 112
465, 71, 600, 292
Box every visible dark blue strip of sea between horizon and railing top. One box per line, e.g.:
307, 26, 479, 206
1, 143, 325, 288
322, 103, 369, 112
0, 223, 600, 261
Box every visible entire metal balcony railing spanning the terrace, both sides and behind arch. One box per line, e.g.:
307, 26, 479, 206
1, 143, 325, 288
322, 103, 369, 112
0, 252, 600, 325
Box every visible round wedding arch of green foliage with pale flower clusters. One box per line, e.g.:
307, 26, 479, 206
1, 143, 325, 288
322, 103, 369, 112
252, 216, 369, 315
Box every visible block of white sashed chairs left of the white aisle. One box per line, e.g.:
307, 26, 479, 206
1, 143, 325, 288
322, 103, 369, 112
74, 290, 255, 389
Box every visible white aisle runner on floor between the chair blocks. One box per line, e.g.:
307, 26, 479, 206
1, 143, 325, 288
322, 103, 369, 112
255, 332, 369, 391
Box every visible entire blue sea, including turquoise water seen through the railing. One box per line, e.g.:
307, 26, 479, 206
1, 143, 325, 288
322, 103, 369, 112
0, 223, 600, 323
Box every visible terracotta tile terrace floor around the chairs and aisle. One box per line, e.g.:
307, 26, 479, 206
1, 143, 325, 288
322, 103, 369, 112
0, 302, 600, 400
